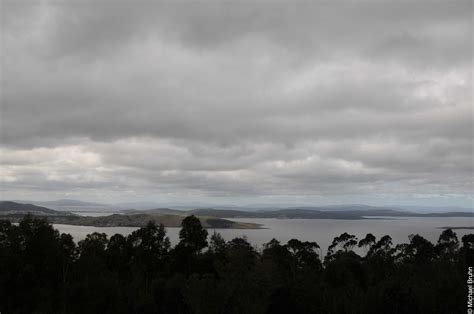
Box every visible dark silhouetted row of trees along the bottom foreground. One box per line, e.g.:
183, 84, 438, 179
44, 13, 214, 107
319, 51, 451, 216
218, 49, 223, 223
0, 215, 474, 314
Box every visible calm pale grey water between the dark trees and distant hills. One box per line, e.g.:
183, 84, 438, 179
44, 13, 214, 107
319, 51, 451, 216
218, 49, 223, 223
54, 217, 474, 254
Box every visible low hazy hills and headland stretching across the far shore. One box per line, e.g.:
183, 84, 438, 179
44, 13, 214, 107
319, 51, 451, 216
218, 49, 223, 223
0, 200, 474, 229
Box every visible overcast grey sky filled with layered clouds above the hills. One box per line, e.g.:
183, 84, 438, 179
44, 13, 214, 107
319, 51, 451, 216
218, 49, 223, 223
0, 0, 474, 206
